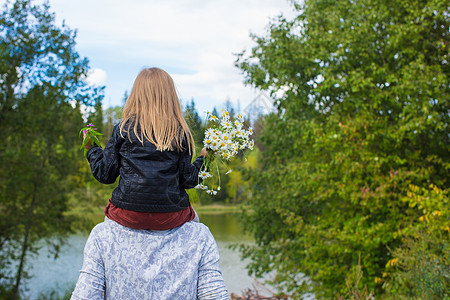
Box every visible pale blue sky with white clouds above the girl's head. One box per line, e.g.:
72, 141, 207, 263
42, 0, 294, 115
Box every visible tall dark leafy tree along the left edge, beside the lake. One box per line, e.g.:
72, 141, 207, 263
0, 0, 103, 299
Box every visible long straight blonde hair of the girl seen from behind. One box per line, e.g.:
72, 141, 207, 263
120, 68, 195, 153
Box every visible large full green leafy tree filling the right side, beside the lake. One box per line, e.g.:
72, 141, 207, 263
236, 0, 450, 298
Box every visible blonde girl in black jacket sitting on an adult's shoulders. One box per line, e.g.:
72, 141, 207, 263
85, 68, 207, 230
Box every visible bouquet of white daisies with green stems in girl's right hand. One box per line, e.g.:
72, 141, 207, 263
195, 109, 254, 195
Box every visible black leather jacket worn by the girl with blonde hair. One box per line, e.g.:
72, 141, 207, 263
87, 124, 203, 212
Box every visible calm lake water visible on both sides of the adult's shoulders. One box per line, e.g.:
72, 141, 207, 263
25, 213, 264, 299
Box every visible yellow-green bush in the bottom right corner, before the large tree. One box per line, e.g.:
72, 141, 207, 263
383, 185, 450, 299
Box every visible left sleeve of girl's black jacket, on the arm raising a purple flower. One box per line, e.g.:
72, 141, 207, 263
86, 124, 124, 184
